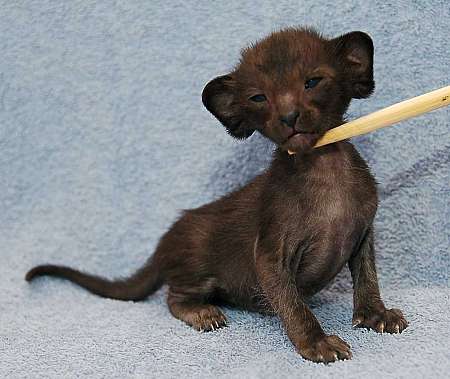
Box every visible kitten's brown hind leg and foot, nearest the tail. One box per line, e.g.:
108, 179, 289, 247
167, 289, 227, 332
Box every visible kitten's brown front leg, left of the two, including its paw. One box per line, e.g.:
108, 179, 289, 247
254, 236, 352, 363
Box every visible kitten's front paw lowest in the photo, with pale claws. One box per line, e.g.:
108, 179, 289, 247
299, 336, 352, 363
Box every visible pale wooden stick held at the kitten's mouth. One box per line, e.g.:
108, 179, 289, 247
289, 86, 450, 154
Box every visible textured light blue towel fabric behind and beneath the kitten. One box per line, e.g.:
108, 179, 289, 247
0, 0, 450, 378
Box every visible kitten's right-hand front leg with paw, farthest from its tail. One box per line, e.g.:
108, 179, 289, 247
349, 226, 408, 333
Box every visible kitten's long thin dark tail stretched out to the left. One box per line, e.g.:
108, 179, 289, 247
25, 260, 163, 301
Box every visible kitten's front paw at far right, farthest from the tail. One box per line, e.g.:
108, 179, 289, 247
352, 306, 408, 333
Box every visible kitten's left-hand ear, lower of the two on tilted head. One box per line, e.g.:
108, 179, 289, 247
202, 74, 255, 139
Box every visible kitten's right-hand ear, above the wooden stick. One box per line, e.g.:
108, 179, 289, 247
331, 32, 375, 99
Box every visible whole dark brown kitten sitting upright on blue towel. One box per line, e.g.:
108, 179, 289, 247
26, 29, 407, 362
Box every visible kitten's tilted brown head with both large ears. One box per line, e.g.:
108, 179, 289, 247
202, 29, 375, 153
